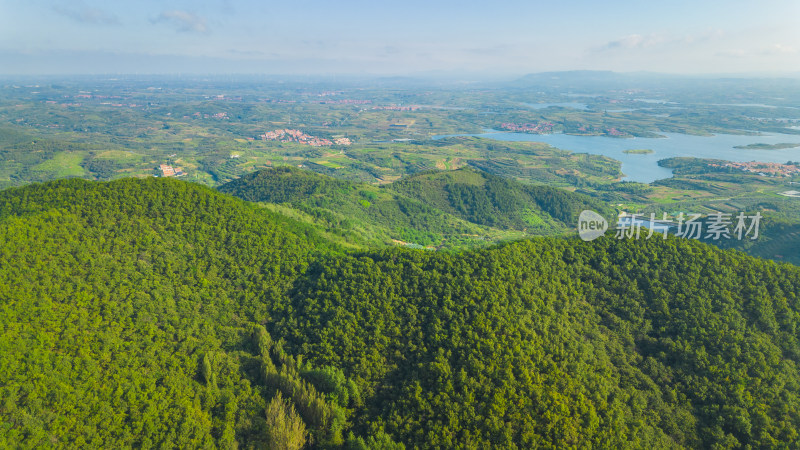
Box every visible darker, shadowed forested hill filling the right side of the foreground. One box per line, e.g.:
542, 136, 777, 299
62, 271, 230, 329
275, 239, 800, 448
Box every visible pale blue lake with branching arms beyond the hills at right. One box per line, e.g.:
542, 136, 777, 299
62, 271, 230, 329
433, 130, 800, 183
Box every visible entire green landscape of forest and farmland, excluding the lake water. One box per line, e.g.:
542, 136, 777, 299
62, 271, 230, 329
0, 73, 800, 449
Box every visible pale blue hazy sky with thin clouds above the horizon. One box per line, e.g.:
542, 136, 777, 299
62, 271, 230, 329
0, 0, 800, 76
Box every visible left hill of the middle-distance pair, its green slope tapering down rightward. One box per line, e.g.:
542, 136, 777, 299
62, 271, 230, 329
219, 167, 521, 248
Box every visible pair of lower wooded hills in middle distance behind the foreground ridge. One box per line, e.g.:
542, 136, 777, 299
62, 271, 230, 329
219, 167, 608, 247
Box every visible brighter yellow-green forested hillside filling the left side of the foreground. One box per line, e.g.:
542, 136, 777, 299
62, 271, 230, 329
0, 179, 360, 448
